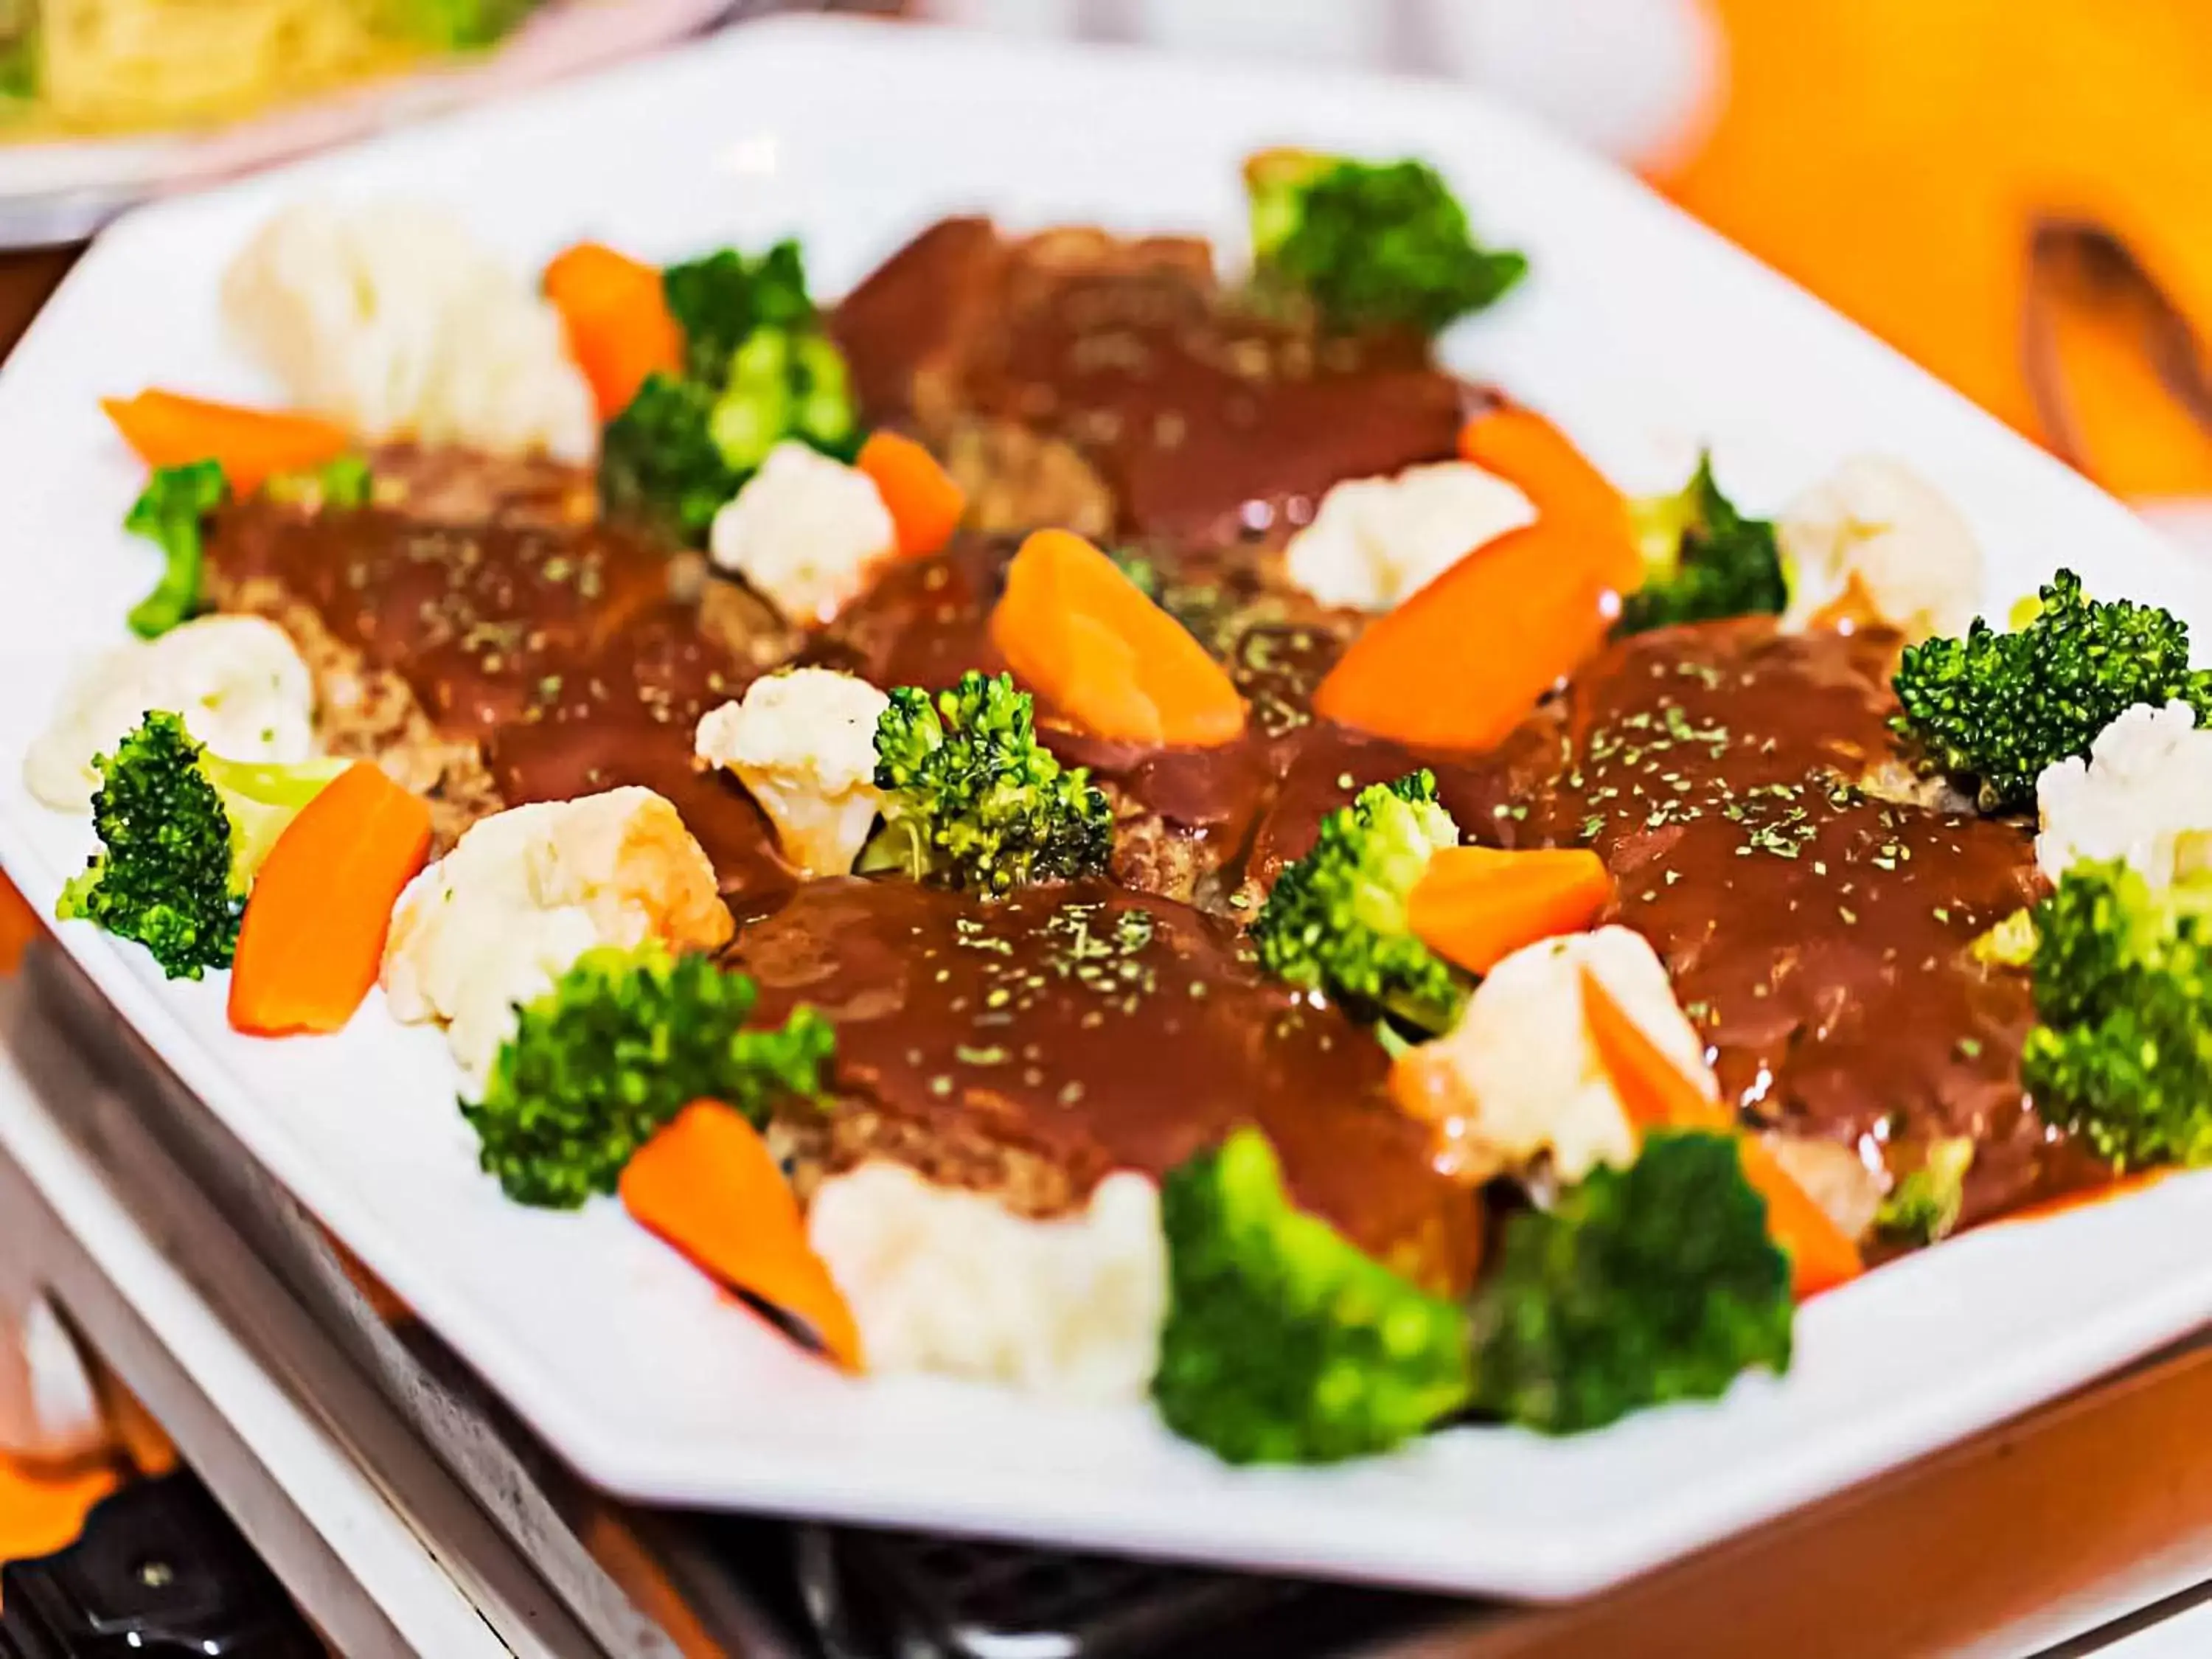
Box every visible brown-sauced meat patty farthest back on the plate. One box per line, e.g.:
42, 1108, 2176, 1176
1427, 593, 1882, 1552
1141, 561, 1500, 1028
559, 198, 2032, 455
832, 219, 1478, 544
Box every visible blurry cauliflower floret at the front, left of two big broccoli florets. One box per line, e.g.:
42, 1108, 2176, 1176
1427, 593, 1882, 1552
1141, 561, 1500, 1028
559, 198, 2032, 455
807, 1164, 1168, 1402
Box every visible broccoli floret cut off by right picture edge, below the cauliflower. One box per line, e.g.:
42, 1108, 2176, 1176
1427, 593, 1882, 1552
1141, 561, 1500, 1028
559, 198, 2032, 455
2020, 863, 2212, 1168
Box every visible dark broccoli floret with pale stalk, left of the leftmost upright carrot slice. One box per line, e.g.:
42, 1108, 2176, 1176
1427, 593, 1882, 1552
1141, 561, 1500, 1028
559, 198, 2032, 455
55, 712, 349, 980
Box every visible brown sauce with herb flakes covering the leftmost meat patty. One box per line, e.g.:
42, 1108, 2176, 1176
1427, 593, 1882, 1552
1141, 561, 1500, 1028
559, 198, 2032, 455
208, 502, 792, 894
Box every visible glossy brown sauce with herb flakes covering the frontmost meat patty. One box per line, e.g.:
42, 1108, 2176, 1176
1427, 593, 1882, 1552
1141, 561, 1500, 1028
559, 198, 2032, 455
732, 878, 1478, 1285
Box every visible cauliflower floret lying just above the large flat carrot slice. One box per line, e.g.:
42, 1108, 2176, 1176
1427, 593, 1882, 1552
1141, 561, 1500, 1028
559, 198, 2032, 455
1285, 460, 1535, 611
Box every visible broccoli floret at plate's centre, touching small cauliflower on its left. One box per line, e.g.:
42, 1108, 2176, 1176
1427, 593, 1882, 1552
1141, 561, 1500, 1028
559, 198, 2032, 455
858, 672, 1113, 896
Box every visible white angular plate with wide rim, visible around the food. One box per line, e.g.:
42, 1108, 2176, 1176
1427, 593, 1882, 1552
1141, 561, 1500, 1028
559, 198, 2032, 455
0, 20, 2212, 1597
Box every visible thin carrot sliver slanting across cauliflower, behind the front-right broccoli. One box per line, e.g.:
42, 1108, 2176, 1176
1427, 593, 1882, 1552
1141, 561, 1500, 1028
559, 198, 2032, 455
1582, 969, 1865, 1301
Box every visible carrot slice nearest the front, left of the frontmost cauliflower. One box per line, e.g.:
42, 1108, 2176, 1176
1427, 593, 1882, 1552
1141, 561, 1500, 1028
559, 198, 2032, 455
622, 1099, 860, 1371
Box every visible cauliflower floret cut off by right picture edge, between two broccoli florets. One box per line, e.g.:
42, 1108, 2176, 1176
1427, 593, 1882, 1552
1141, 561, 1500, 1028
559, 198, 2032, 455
2035, 701, 2212, 887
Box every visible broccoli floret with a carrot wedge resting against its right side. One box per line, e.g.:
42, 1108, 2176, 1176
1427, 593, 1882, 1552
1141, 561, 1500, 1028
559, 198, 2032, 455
1252, 770, 1467, 1033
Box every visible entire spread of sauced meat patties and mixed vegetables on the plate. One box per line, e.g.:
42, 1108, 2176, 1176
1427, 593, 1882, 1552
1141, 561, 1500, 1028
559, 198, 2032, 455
31, 153, 2212, 1462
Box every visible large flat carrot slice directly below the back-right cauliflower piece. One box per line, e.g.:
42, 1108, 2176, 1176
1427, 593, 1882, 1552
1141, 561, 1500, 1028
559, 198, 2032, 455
1314, 518, 1613, 752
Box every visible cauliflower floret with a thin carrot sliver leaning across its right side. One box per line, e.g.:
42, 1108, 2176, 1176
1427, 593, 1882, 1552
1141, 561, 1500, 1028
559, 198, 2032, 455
1398, 927, 1714, 1183
